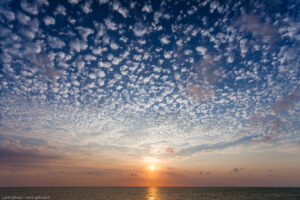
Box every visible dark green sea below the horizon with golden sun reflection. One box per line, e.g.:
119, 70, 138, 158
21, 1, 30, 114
0, 187, 300, 200
